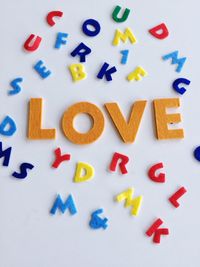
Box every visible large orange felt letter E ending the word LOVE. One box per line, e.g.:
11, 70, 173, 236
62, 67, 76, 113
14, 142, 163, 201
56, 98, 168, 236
154, 98, 184, 140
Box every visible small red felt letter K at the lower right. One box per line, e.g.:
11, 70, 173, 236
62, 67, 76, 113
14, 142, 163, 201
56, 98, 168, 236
146, 219, 169, 244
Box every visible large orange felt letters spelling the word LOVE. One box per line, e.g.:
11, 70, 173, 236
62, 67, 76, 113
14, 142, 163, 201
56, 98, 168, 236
28, 98, 184, 145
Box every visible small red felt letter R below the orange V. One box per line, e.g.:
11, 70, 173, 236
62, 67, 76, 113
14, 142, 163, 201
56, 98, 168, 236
109, 152, 129, 174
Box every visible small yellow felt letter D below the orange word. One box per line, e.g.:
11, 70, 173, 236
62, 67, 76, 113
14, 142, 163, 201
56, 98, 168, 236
74, 162, 94, 183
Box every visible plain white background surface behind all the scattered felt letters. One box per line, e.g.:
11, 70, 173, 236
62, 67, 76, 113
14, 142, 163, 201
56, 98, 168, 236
0, 0, 200, 267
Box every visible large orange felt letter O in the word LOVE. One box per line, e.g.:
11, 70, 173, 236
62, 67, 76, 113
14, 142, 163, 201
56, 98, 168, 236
61, 102, 104, 145
